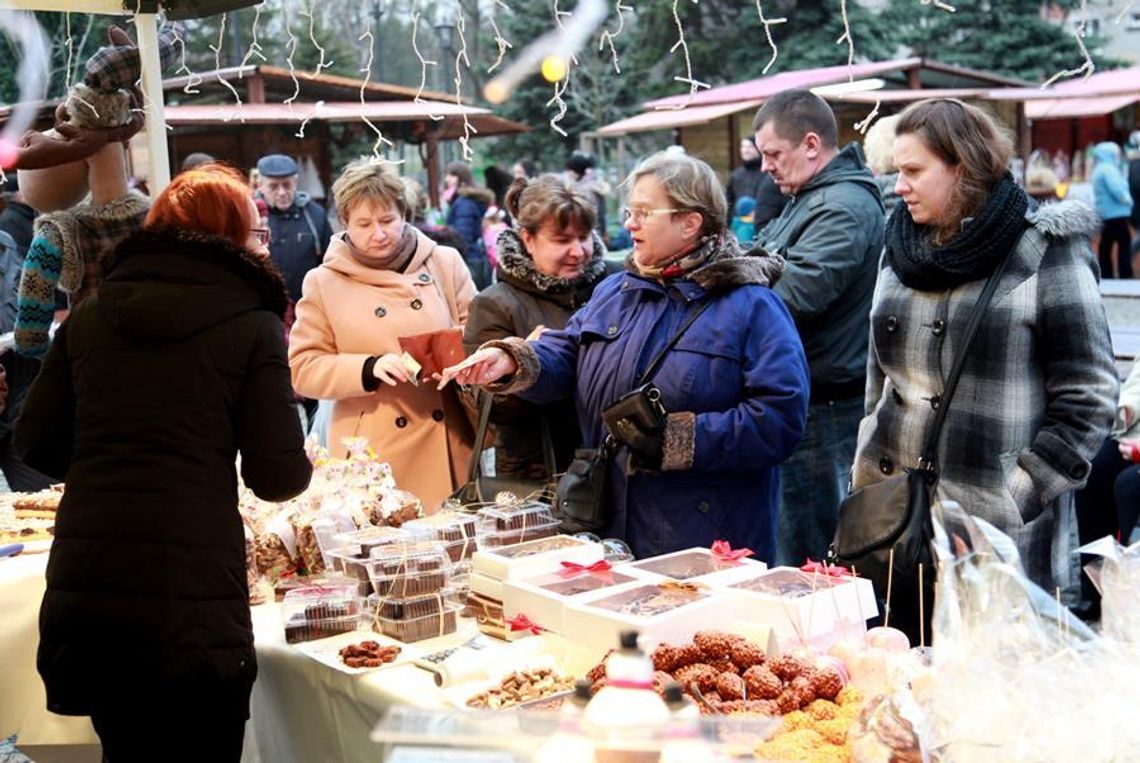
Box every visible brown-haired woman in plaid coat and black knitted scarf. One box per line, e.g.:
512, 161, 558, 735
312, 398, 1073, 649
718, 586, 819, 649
852, 99, 1119, 591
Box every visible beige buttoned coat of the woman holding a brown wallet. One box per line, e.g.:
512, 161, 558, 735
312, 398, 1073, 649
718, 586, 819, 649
288, 228, 475, 512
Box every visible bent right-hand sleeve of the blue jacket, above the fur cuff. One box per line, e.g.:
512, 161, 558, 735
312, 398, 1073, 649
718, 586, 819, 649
693, 289, 809, 471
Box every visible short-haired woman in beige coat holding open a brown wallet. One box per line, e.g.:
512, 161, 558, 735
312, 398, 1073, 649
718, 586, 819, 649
288, 160, 475, 511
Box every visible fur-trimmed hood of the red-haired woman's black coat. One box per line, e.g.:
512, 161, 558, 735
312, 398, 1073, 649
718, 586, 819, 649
98, 221, 288, 340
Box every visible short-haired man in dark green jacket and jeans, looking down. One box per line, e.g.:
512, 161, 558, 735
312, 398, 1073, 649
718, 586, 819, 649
752, 90, 885, 565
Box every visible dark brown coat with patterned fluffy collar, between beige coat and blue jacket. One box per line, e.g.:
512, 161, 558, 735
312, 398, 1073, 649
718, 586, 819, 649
463, 229, 620, 479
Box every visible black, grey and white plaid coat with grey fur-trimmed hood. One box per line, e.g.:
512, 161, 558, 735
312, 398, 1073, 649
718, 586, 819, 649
852, 202, 1119, 591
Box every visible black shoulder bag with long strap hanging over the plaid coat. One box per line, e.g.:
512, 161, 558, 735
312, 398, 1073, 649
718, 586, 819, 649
828, 250, 1010, 643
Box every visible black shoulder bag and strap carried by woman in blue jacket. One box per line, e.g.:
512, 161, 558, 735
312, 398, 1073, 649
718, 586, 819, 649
554, 300, 711, 533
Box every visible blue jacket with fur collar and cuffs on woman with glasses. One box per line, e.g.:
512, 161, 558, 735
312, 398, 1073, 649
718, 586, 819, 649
512, 236, 809, 561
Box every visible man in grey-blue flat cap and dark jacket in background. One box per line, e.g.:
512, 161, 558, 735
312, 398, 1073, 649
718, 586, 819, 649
258, 154, 333, 302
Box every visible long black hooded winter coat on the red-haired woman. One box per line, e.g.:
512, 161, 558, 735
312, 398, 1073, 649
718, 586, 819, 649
16, 224, 311, 717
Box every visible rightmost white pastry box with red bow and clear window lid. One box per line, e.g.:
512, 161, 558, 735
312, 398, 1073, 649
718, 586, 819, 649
725, 567, 879, 648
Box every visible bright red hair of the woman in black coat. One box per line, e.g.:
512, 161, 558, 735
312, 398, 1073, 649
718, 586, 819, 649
144, 164, 257, 246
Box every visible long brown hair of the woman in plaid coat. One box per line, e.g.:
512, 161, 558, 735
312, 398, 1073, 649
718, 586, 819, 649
895, 98, 1013, 245
